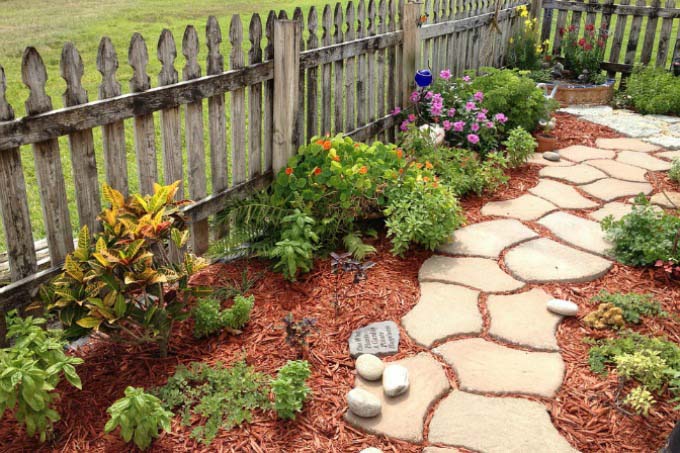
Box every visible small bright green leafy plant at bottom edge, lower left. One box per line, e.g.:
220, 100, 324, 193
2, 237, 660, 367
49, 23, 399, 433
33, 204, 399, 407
104, 387, 173, 450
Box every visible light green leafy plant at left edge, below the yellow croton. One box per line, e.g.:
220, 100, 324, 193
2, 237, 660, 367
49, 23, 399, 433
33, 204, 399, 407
0, 310, 83, 442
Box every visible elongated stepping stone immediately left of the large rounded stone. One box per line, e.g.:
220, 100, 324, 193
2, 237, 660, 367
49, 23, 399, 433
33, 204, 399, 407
418, 255, 524, 293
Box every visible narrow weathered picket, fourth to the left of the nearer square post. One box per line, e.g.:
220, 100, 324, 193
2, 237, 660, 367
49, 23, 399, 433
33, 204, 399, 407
205, 16, 229, 193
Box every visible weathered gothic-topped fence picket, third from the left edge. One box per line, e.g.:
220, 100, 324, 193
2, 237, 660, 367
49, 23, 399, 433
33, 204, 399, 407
60, 43, 101, 232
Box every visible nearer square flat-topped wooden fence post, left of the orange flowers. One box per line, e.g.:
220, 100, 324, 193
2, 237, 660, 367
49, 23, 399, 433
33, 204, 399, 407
272, 20, 301, 174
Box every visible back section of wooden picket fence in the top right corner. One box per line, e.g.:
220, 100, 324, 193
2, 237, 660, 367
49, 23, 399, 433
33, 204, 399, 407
541, 0, 680, 77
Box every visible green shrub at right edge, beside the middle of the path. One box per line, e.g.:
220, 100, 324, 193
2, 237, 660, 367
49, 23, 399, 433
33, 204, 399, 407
602, 195, 680, 266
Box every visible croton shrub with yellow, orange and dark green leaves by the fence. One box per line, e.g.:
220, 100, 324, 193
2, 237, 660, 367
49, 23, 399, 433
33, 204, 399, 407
41, 181, 207, 356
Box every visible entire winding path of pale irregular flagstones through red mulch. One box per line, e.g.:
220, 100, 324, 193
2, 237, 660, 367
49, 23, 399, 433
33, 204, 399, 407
346, 132, 680, 453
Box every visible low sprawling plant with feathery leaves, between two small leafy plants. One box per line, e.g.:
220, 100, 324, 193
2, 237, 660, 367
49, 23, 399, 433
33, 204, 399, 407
154, 360, 271, 444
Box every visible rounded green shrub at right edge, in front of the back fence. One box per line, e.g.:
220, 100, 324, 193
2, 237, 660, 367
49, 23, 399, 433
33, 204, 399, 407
625, 66, 680, 114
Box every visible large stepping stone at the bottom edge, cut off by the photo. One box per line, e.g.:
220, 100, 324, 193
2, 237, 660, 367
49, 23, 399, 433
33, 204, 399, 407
428, 390, 578, 453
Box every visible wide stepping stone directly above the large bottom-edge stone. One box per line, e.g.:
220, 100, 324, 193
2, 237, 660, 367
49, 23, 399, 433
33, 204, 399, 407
433, 338, 564, 398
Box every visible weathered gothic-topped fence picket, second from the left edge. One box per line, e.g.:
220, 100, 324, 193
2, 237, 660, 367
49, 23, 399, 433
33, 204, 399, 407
21, 47, 73, 266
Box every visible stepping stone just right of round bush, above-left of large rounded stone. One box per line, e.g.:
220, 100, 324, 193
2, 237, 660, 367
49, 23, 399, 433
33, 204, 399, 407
437, 219, 538, 258
